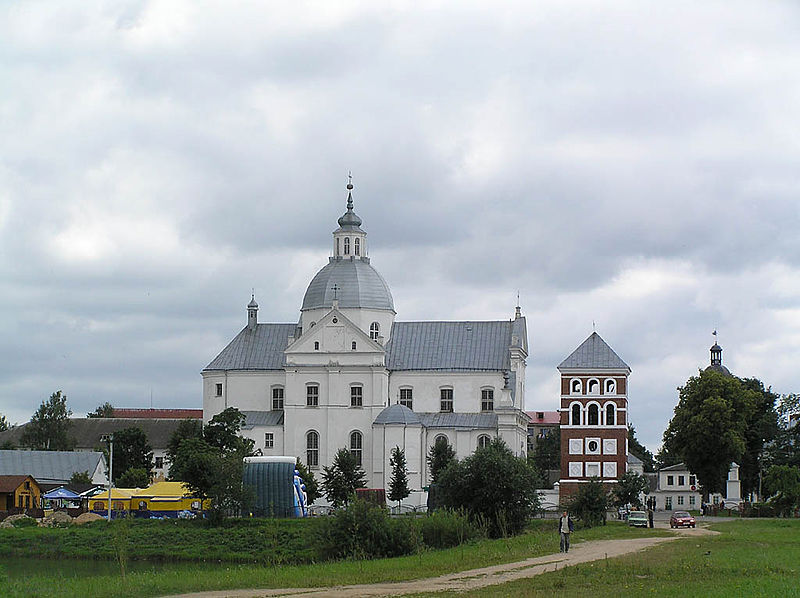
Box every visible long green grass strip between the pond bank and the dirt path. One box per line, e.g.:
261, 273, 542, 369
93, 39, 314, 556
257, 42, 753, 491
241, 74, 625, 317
0, 521, 669, 598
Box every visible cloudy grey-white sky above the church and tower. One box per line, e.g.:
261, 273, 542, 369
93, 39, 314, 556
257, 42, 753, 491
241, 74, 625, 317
0, 0, 800, 450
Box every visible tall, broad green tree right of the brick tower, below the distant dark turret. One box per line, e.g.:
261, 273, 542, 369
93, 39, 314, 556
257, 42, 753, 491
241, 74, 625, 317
664, 370, 759, 498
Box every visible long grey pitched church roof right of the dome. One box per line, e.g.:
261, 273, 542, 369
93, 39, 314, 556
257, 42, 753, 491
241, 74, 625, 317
386, 318, 527, 371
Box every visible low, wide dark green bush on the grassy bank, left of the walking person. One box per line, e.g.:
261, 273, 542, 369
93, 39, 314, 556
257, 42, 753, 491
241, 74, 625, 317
317, 500, 420, 560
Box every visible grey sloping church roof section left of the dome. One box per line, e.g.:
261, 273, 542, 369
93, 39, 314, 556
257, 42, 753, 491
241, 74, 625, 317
205, 324, 297, 370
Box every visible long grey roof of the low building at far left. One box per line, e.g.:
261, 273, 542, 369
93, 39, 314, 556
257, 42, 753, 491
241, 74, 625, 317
0, 450, 103, 483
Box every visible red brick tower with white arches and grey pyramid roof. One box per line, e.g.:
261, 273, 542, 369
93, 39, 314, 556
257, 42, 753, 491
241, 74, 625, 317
558, 332, 631, 503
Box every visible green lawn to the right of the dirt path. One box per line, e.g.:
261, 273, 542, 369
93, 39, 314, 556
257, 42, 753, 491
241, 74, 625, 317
415, 519, 800, 598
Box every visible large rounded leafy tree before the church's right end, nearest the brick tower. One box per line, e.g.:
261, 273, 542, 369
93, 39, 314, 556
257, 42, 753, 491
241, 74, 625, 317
437, 438, 539, 537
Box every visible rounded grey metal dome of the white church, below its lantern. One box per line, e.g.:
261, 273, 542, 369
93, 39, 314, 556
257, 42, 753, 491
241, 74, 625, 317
301, 257, 394, 311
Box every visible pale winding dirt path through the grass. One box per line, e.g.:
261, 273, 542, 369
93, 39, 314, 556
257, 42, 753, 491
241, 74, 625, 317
170, 524, 719, 598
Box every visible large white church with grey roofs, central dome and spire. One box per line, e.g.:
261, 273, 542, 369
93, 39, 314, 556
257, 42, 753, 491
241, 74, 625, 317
202, 184, 529, 504
